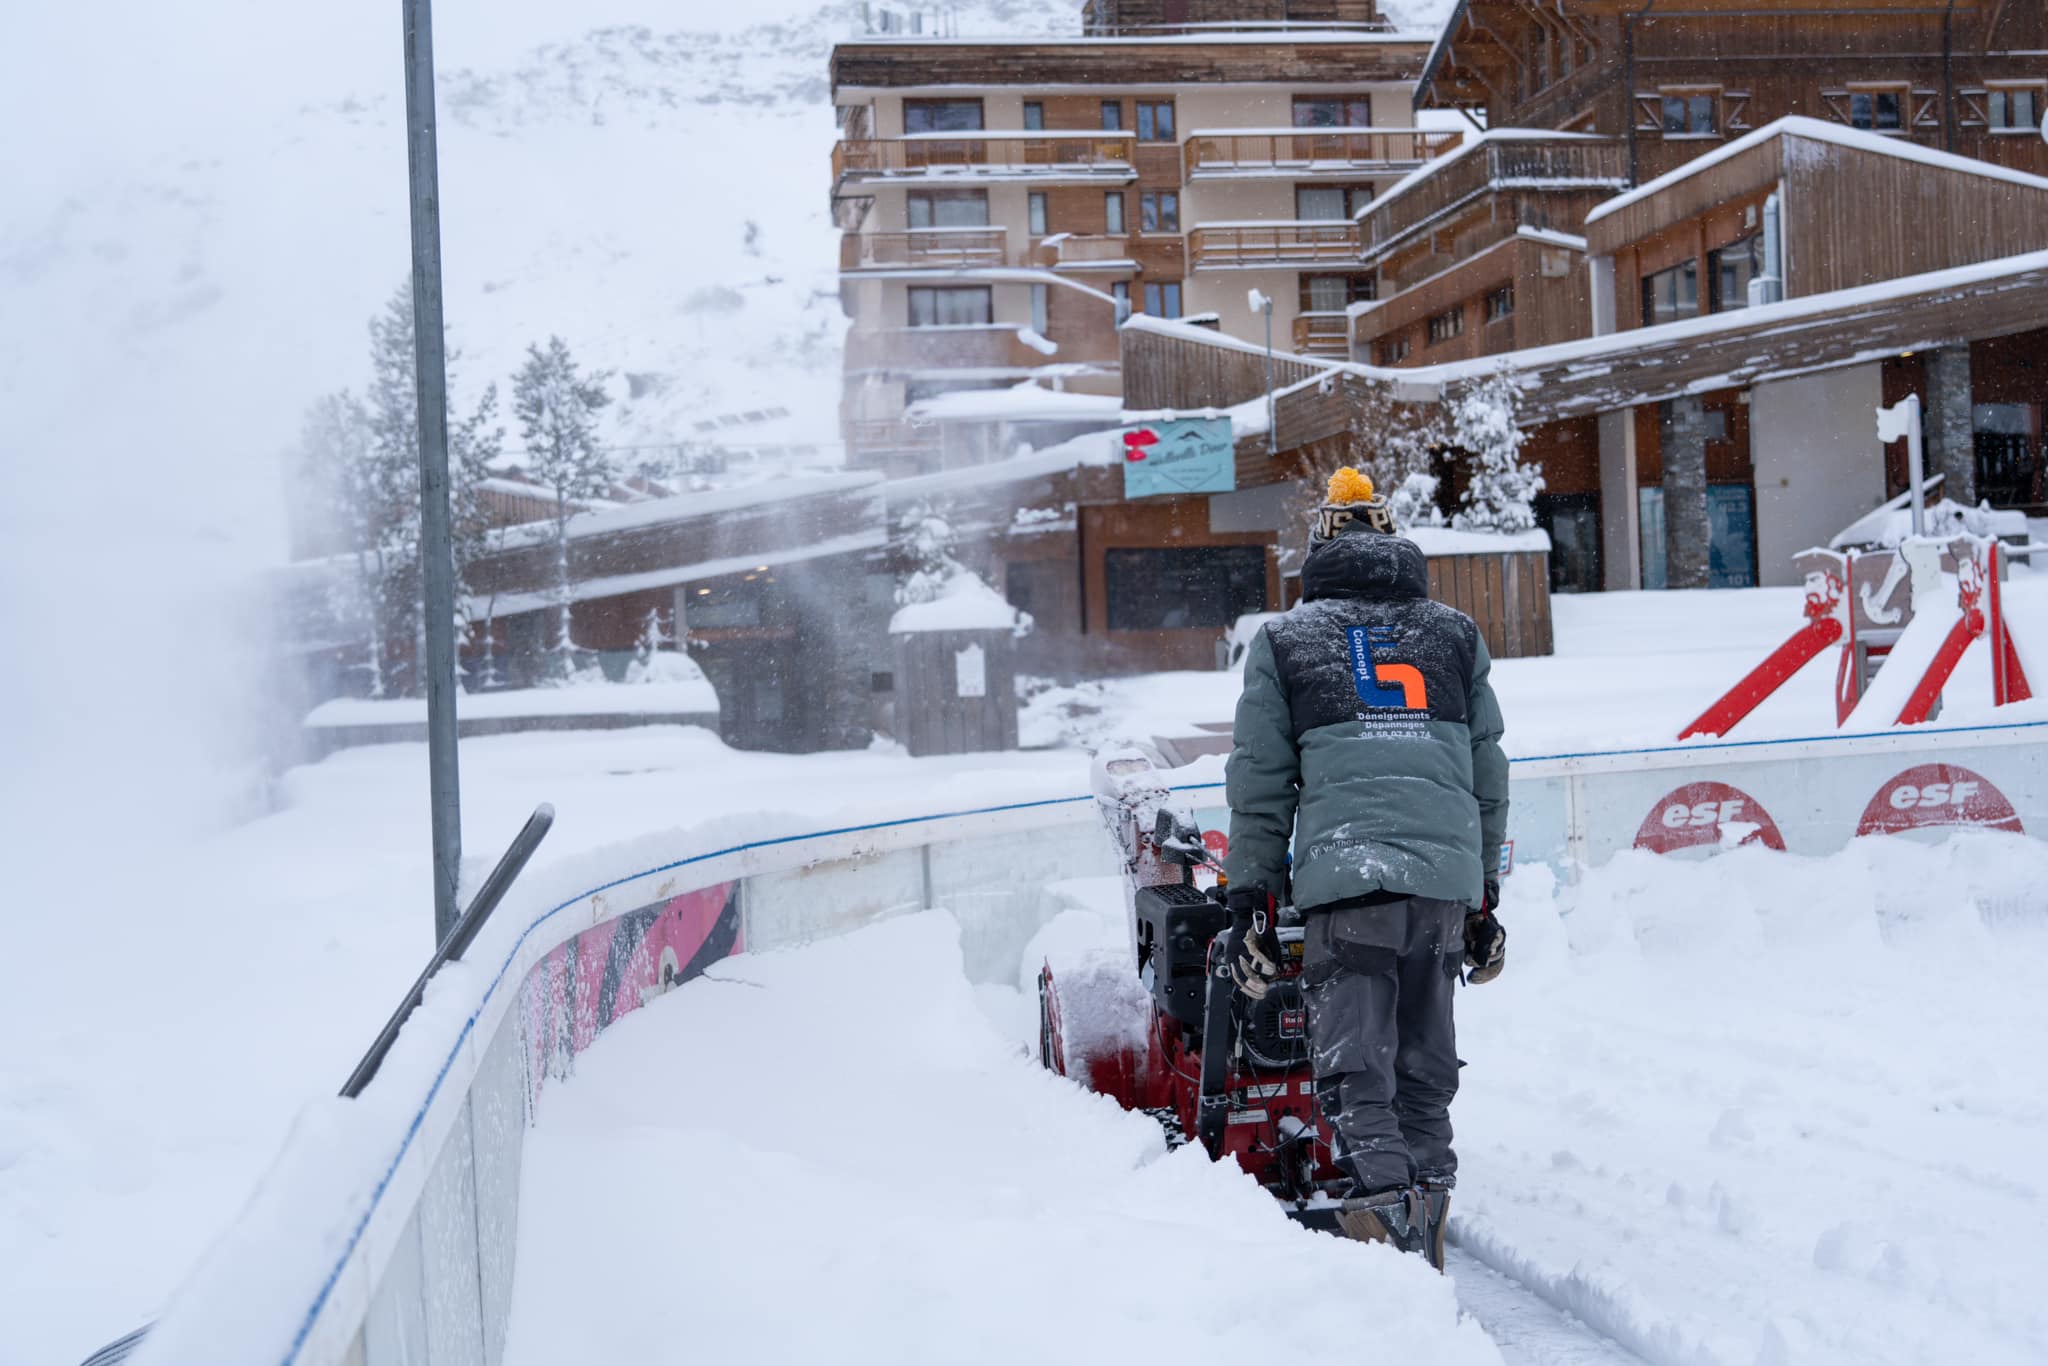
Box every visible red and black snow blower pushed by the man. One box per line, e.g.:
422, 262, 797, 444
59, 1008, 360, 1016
1038, 750, 1341, 1229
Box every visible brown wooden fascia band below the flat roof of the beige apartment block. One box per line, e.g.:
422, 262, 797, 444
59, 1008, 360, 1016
831, 37, 1430, 90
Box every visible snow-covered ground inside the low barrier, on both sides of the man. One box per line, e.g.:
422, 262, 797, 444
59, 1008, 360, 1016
491, 834, 2048, 1366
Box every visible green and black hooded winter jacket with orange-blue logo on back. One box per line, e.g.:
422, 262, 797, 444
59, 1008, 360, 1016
1225, 522, 1507, 909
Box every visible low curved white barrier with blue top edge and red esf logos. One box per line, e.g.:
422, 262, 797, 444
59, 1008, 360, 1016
135, 723, 2048, 1366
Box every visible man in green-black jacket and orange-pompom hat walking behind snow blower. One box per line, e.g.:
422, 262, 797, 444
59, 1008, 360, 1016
1227, 469, 1507, 1268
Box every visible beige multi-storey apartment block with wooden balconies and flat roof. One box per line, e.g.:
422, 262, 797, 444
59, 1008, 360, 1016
831, 0, 1458, 473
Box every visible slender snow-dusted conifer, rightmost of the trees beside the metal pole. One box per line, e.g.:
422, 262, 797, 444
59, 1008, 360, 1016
512, 336, 612, 682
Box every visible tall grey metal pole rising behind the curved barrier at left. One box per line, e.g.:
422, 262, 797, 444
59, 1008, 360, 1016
403, 0, 463, 944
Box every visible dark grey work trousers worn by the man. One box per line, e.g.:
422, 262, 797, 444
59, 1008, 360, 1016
1303, 897, 1466, 1194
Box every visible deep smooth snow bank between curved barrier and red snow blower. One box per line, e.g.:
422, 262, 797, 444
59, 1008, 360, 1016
487, 913, 1499, 1366
